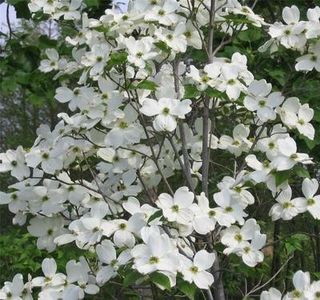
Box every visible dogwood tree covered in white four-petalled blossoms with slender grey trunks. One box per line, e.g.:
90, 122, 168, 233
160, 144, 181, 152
0, 0, 320, 300
